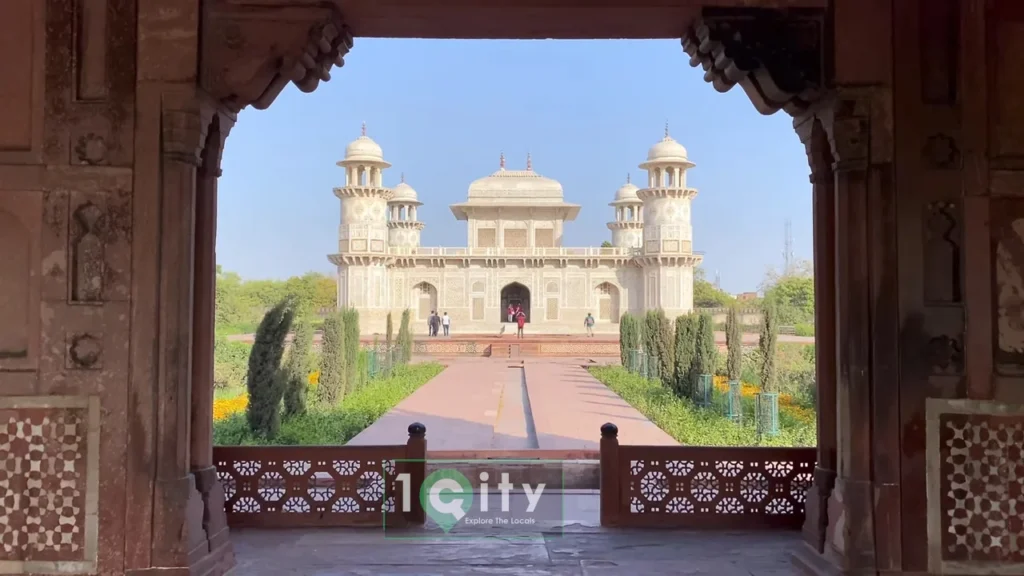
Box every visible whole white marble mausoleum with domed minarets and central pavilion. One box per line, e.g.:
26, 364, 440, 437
329, 126, 702, 334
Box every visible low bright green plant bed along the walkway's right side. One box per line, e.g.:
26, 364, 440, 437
590, 366, 817, 446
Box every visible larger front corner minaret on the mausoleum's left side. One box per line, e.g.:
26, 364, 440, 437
329, 124, 392, 315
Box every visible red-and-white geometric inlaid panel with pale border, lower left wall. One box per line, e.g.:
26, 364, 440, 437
0, 397, 98, 574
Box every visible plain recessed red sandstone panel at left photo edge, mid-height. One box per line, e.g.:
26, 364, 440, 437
0, 192, 43, 371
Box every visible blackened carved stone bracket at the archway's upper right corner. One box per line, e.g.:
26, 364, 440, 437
683, 8, 827, 116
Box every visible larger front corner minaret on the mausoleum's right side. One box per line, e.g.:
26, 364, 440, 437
637, 124, 703, 317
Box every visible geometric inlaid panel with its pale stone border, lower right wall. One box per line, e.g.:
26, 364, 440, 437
927, 399, 1024, 574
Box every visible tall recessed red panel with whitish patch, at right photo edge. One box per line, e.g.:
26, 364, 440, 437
991, 199, 1024, 375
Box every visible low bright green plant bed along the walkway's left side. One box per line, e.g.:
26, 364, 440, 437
213, 363, 444, 446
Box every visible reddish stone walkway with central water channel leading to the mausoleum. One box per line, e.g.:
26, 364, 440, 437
349, 358, 677, 451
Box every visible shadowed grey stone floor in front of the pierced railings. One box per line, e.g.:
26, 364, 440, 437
231, 492, 800, 576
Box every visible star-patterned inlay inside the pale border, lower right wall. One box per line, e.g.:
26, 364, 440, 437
938, 413, 1024, 573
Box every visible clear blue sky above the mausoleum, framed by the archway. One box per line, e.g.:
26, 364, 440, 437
217, 39, 812, 292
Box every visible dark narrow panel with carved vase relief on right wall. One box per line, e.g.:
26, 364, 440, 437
924, 201, 964, 303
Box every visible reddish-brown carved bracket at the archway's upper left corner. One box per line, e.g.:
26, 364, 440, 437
200, 0, 352, 112
